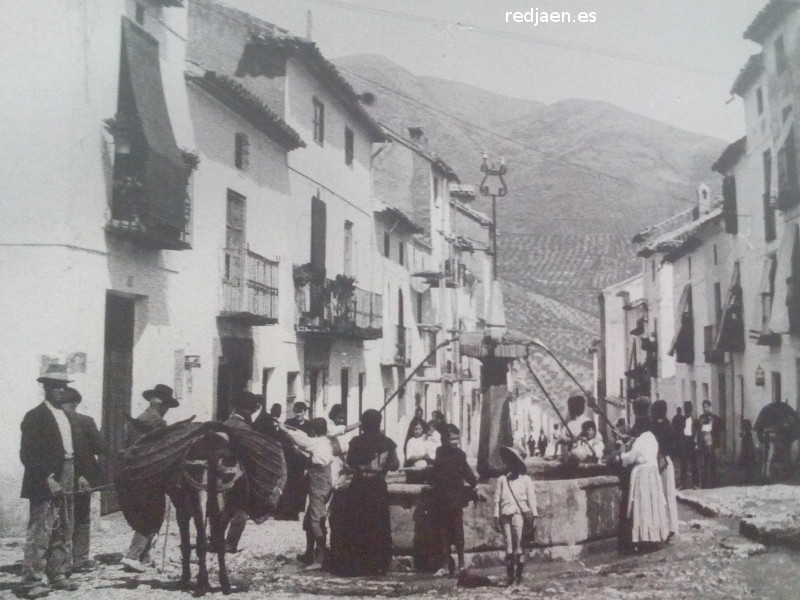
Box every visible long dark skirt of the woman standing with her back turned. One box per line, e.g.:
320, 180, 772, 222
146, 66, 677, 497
328, 476, 392, 576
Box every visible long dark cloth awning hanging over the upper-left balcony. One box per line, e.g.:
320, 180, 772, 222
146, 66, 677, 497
120, 18, 189, 231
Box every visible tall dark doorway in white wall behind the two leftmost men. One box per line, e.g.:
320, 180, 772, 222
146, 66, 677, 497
100, 293, 136, 515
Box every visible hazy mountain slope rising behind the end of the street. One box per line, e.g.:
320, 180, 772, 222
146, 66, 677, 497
335, 55, 725, 393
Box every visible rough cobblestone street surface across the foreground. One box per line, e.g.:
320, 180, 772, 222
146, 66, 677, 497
0, 500, 800, 600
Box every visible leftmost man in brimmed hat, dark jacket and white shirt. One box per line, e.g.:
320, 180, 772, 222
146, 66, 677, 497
19, 365, 78, 598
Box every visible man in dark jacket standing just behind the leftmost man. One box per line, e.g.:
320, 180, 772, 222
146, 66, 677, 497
61, 387, 106, 573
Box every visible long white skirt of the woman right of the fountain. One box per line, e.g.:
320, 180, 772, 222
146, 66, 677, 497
628, 464, 670, 544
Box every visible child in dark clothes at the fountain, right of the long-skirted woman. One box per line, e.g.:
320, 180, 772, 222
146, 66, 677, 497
431, 423, 478, 577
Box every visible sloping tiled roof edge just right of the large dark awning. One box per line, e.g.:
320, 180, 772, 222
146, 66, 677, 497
186, 71, 306, 150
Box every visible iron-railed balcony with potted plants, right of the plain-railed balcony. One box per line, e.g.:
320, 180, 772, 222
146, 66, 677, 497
295, 278, 383, 340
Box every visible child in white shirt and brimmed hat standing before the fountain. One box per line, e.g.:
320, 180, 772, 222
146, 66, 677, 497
494, 446, 539, 585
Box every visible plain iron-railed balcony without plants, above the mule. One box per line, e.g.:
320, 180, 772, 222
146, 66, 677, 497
220, 248, 278, 325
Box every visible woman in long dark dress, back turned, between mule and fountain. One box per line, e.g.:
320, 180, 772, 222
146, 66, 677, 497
329, 409, 400, 575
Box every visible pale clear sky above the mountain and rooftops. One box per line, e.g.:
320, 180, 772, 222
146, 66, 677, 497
220, 0, 767, 141
